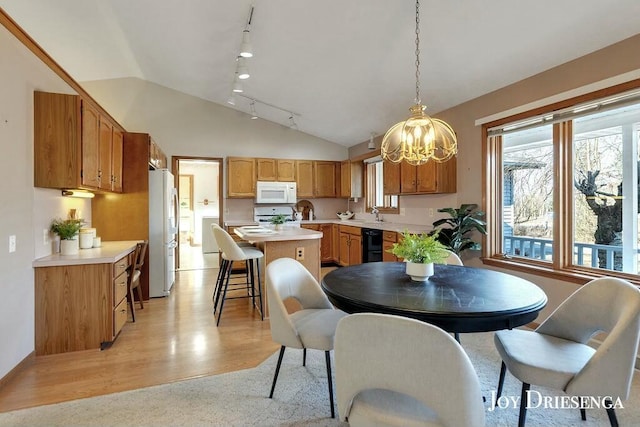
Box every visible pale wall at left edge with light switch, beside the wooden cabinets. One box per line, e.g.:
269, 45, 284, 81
0, 22, 95, 378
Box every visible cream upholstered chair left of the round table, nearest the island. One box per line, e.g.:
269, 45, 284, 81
266, 258, 346, 418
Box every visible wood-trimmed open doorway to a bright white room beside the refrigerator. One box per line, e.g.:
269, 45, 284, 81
172, 156, 224, 270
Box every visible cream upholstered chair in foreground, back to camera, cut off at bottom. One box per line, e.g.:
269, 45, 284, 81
335, 313, 485, 427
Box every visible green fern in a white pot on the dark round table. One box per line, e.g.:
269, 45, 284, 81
387, 230, 449, 282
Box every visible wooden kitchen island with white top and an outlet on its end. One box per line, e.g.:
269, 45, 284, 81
234, 226, 322, 317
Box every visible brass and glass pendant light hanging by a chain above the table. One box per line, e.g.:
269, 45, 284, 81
380, 0, 458, 166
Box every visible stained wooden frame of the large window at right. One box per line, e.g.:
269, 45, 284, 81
482, 79, 640, 285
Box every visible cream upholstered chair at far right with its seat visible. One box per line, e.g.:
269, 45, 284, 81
494, 277, 640, 426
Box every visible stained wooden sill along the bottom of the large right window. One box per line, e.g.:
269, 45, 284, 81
482, 258, 640, 286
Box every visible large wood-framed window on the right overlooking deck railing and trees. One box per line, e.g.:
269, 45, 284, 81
484, 88, 640, 282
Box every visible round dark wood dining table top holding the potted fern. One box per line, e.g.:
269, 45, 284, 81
321, 262, 547, 333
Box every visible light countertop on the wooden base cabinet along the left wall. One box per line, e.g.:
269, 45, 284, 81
32, 240, 138, 268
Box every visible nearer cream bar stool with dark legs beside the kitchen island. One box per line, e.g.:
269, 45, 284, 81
211, 224, 264, 325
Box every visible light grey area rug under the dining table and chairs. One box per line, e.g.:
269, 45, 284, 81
0, 333, 640, 427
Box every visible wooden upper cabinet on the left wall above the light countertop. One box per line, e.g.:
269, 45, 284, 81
34, 92, 123, 192
